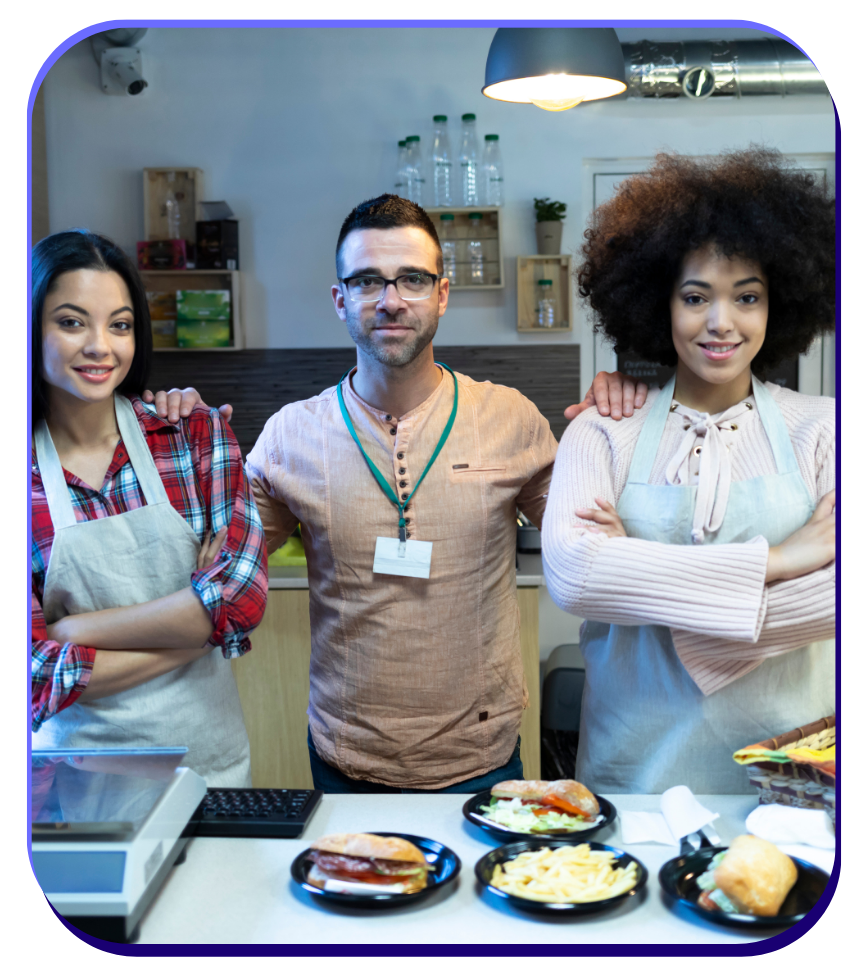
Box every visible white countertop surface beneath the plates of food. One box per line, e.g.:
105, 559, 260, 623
138, 794, 812, 944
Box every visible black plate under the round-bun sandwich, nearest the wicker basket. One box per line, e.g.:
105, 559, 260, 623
659, 848, 830, 927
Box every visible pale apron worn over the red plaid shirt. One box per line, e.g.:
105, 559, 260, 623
33, 395, 251, 787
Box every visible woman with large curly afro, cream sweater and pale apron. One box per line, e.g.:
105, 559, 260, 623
542, 149, 835, 794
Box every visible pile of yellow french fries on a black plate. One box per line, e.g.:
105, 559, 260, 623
491, 845, 638, 903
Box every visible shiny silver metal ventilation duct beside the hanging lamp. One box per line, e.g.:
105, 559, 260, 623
621, 38, 838, 99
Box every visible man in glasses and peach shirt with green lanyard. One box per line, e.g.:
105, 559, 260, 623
147, 196, 646, 792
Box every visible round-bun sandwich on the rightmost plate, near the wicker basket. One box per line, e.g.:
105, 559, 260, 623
696, 834, 798, 916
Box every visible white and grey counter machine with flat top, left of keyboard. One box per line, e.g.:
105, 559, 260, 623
31, 747, 207, 942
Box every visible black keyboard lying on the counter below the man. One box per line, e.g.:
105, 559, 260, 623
190, 787, 322, 838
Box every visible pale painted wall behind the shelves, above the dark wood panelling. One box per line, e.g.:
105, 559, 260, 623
45, 28, 834, 356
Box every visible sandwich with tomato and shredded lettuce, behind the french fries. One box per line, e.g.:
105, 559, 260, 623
480, 780, 599, 834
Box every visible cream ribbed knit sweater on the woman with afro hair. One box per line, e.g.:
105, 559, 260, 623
542, 379, 836, 695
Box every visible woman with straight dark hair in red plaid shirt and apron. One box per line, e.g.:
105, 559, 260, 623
31, 230, 267, 787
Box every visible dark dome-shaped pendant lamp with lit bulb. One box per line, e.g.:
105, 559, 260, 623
482, 27, 626, 111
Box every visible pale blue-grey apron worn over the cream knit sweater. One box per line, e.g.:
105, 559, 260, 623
576, 378, 835, 794
